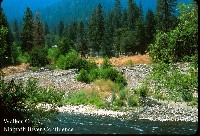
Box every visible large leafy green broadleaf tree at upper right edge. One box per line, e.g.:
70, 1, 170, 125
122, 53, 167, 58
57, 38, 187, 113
150, 1, 198, 63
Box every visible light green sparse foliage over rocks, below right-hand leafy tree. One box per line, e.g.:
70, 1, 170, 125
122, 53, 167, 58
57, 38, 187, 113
144, 63, 198, 101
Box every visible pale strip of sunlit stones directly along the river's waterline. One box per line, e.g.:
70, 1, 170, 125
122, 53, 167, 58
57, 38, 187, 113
37, 102, 198, 122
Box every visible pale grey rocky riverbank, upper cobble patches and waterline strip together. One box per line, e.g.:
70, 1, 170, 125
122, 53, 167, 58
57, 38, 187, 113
4, 64, 198, 122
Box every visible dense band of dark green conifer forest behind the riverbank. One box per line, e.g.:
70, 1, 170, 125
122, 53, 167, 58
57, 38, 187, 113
1, 0, 197, 67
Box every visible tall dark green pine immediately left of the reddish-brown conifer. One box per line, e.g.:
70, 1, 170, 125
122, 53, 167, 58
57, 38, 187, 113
20, 7, 34, 52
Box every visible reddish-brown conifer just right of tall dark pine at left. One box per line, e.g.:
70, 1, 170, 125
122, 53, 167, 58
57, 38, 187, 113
34, 13, 45, 47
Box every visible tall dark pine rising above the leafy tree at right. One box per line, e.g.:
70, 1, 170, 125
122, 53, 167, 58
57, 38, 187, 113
156, 0, 177, 32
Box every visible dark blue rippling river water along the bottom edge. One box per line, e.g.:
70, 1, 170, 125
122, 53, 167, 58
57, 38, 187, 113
41, 113, 198, 135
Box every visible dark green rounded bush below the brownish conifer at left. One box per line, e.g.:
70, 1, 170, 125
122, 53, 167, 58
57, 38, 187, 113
30, 47, 49, 67
